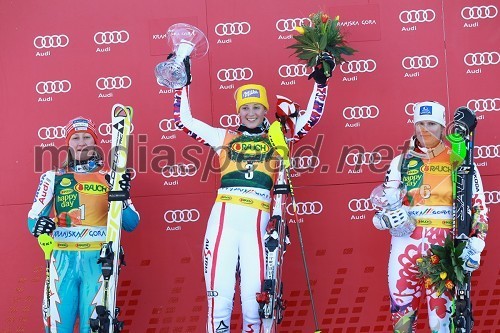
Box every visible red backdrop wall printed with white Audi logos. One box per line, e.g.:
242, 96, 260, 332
0, 0, 500, 333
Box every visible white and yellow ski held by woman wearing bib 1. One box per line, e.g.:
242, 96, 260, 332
90, 104, 133, 333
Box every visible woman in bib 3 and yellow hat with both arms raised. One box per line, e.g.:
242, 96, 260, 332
174, 71, 327, 333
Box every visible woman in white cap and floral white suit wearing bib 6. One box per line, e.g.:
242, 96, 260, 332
373, 102, 488, 333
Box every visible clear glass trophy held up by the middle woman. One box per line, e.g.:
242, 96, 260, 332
155, 23, 208, 89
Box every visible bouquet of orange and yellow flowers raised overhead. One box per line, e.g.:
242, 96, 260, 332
287, 11, 357, 76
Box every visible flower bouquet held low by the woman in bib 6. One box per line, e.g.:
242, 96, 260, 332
417, 236, 468, 295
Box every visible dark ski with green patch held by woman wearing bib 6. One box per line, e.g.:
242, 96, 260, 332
448, 107, 477, 333
